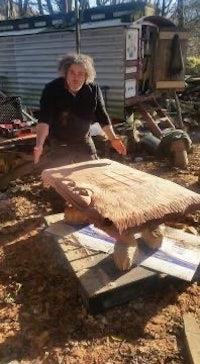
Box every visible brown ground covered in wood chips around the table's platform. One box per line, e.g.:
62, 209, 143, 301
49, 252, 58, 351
0, 145, 200, 364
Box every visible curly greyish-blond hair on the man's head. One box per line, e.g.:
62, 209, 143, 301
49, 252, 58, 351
58, 53, 96, 83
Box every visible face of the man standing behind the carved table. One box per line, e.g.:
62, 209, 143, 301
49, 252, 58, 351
66, 64, 86, 93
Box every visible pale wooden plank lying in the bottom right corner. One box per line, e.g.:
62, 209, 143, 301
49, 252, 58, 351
183, 313, 200, 364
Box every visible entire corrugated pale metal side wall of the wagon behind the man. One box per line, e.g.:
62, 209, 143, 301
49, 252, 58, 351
0, 26, 125, 118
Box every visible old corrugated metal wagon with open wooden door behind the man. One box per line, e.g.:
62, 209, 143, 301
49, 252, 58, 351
0, 2, 187, 121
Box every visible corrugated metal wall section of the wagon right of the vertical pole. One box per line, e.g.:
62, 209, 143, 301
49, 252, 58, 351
81, 26, 125, 118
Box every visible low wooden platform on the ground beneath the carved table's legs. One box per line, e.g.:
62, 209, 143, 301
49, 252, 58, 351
45, 214, 158, 314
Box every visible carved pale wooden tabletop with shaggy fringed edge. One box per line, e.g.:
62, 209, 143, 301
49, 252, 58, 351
42, 159, 200, 233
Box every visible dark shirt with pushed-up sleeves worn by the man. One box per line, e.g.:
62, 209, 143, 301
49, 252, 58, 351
38, 78, 111, 141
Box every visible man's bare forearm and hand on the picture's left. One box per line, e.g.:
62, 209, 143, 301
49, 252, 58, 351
34, 123, 49, 164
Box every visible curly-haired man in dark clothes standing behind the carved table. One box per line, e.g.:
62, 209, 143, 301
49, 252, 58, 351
34, 53, 126, 167
